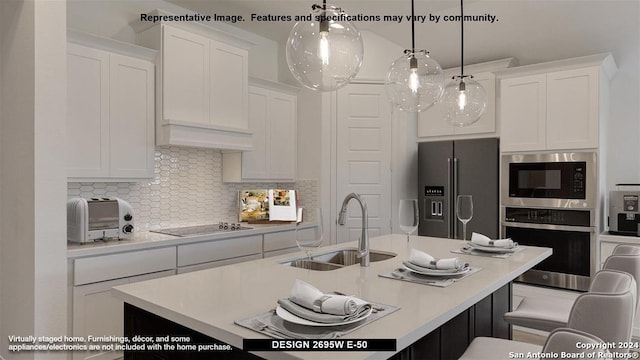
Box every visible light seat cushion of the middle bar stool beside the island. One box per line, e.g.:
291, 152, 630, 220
504, 297, 574, 331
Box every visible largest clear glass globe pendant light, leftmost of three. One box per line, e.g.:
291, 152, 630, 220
285, 0, 364, 91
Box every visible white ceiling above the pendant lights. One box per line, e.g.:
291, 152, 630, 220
170, 0, 640, 69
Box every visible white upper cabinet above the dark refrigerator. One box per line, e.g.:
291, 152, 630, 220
418, 58, 517, 141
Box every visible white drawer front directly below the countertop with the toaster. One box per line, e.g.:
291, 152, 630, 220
73, 247, 176, 285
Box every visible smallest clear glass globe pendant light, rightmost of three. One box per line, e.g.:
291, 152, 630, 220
442, 0, 487, 127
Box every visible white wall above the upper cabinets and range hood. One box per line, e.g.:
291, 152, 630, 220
67, 0, 278, 81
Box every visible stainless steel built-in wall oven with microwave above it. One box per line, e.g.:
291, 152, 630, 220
501, 152, 598, 291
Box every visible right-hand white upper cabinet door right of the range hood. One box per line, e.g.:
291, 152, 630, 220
268, 92, 297, 180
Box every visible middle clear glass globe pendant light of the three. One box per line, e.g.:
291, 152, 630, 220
385, 0, 444, 112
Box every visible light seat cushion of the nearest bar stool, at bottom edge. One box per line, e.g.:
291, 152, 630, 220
460, 337, 542, 360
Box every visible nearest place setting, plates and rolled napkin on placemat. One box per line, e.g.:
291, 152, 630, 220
235, 279, 399, 339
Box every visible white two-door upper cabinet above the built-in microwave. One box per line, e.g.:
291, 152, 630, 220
498, 54, 616, 152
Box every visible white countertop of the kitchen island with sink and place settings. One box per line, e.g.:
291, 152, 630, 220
112, 235, 552, 359
